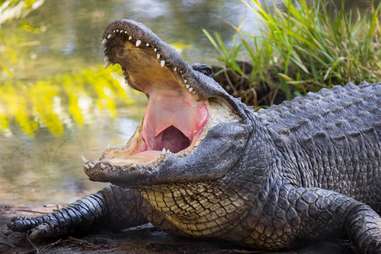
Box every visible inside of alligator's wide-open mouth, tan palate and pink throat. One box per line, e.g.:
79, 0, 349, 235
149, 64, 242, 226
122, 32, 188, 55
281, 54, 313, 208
92, 19, 208, 165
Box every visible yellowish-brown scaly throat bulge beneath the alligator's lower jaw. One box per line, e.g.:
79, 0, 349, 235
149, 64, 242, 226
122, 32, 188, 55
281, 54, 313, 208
141, 183, 247, 237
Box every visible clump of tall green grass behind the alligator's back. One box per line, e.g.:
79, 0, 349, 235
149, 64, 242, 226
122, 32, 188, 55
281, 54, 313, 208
204, 0, 381, 106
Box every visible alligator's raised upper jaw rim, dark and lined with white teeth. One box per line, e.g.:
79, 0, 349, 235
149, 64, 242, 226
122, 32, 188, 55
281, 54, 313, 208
102, 19, 250, 121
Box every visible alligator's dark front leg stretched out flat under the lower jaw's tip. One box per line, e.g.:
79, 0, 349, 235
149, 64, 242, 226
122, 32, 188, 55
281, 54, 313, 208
8, 185, 146, 239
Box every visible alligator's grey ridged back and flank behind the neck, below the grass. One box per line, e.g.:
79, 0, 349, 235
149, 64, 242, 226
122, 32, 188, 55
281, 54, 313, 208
258, 84, 381, 211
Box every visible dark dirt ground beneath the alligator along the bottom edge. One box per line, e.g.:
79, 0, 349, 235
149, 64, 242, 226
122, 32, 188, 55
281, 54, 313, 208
0, 205, 352, 254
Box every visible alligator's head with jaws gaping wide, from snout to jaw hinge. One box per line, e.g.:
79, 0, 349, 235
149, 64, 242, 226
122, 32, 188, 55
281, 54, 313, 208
85, 19, 252, 187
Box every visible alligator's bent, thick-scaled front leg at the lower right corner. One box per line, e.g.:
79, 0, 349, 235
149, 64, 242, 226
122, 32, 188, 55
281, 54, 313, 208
254, 186, 381, 254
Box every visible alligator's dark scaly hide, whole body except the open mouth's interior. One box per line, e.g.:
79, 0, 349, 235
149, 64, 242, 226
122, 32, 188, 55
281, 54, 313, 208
9, 20, 381, 254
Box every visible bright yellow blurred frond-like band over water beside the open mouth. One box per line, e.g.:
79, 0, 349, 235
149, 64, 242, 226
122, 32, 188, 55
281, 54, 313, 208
0, 66, 132, 136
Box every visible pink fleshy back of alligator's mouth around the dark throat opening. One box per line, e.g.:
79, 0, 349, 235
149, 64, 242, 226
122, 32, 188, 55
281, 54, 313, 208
143, 89, 208, 152
